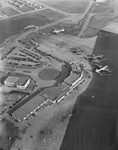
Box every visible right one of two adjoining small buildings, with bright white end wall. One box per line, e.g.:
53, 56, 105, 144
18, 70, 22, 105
16, 77, 30, 89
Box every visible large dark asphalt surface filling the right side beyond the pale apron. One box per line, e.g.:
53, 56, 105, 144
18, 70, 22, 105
60, 32, 118, 150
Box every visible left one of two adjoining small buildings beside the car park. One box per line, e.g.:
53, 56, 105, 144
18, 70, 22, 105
4, 76, 19, 87
